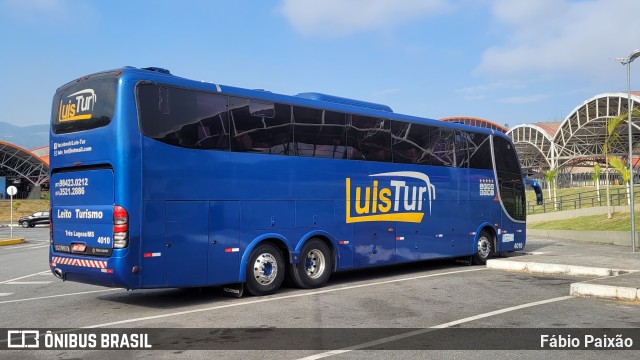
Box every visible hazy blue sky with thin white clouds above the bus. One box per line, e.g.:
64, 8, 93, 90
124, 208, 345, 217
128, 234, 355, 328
0, 0, 640, 127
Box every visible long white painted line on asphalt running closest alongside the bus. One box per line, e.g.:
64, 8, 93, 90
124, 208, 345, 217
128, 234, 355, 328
84, 267, 487, 329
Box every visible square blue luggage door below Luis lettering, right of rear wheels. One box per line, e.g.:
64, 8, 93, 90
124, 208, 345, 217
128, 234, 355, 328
353, 221, 396, 267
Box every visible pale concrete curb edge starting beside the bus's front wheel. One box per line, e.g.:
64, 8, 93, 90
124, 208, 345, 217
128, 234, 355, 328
487, 259, 634, 277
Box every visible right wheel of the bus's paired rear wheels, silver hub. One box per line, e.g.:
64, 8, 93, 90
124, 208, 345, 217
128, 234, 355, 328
289, 239, 333, 289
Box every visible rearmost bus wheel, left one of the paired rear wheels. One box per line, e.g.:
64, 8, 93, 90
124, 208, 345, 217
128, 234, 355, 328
246, 243, 285, 296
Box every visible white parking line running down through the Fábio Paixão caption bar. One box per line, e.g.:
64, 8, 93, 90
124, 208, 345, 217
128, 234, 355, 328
298, 296, 574, 360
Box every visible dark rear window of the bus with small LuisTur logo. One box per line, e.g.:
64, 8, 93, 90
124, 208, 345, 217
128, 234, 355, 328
51, 75, 117, 134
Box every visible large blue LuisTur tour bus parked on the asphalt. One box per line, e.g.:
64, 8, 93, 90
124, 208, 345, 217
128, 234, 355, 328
49, 67, 525, 295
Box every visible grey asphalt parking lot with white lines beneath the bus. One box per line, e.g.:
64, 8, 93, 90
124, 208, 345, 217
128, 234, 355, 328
0, 227, 640, 359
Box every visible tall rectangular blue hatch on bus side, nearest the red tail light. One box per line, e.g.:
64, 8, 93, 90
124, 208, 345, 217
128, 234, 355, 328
164, 201, 209, 287
